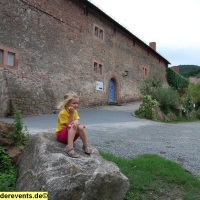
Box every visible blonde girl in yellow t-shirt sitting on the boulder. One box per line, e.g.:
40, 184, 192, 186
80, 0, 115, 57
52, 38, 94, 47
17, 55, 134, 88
56, 92, 92, 158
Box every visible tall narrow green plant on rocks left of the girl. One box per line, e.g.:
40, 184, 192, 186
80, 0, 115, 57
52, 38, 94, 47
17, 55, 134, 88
8, 106, 30, 145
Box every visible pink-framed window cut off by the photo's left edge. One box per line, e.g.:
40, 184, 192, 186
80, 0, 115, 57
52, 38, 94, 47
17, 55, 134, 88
0, 45, 19, 69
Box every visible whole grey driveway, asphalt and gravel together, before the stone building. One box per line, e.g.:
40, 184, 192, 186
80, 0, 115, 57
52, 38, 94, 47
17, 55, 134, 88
0, 104, 200, 178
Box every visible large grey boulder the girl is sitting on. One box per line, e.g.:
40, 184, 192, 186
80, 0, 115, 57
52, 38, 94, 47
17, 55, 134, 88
17, 133, 129, 200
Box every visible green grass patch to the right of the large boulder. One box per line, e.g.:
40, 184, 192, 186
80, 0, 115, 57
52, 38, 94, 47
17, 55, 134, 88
100, 152, 200, 200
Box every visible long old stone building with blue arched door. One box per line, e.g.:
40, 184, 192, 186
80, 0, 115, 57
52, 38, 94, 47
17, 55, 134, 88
0, 0, 169, 116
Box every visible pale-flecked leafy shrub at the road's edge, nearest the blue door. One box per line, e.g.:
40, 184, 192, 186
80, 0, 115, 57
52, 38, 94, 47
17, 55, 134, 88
135, 95, 159, 120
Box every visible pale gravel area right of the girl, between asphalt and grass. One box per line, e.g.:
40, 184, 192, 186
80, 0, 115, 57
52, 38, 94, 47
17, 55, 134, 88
87, 118, 200, 178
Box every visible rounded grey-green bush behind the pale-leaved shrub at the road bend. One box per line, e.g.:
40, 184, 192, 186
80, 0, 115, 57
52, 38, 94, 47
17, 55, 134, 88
152, 87, 179, 113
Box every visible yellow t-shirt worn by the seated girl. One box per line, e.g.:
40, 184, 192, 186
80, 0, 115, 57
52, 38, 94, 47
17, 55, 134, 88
56, 109, 80, 134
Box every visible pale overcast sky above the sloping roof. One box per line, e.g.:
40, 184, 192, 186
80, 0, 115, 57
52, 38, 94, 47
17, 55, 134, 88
89, 0, 200, 67
